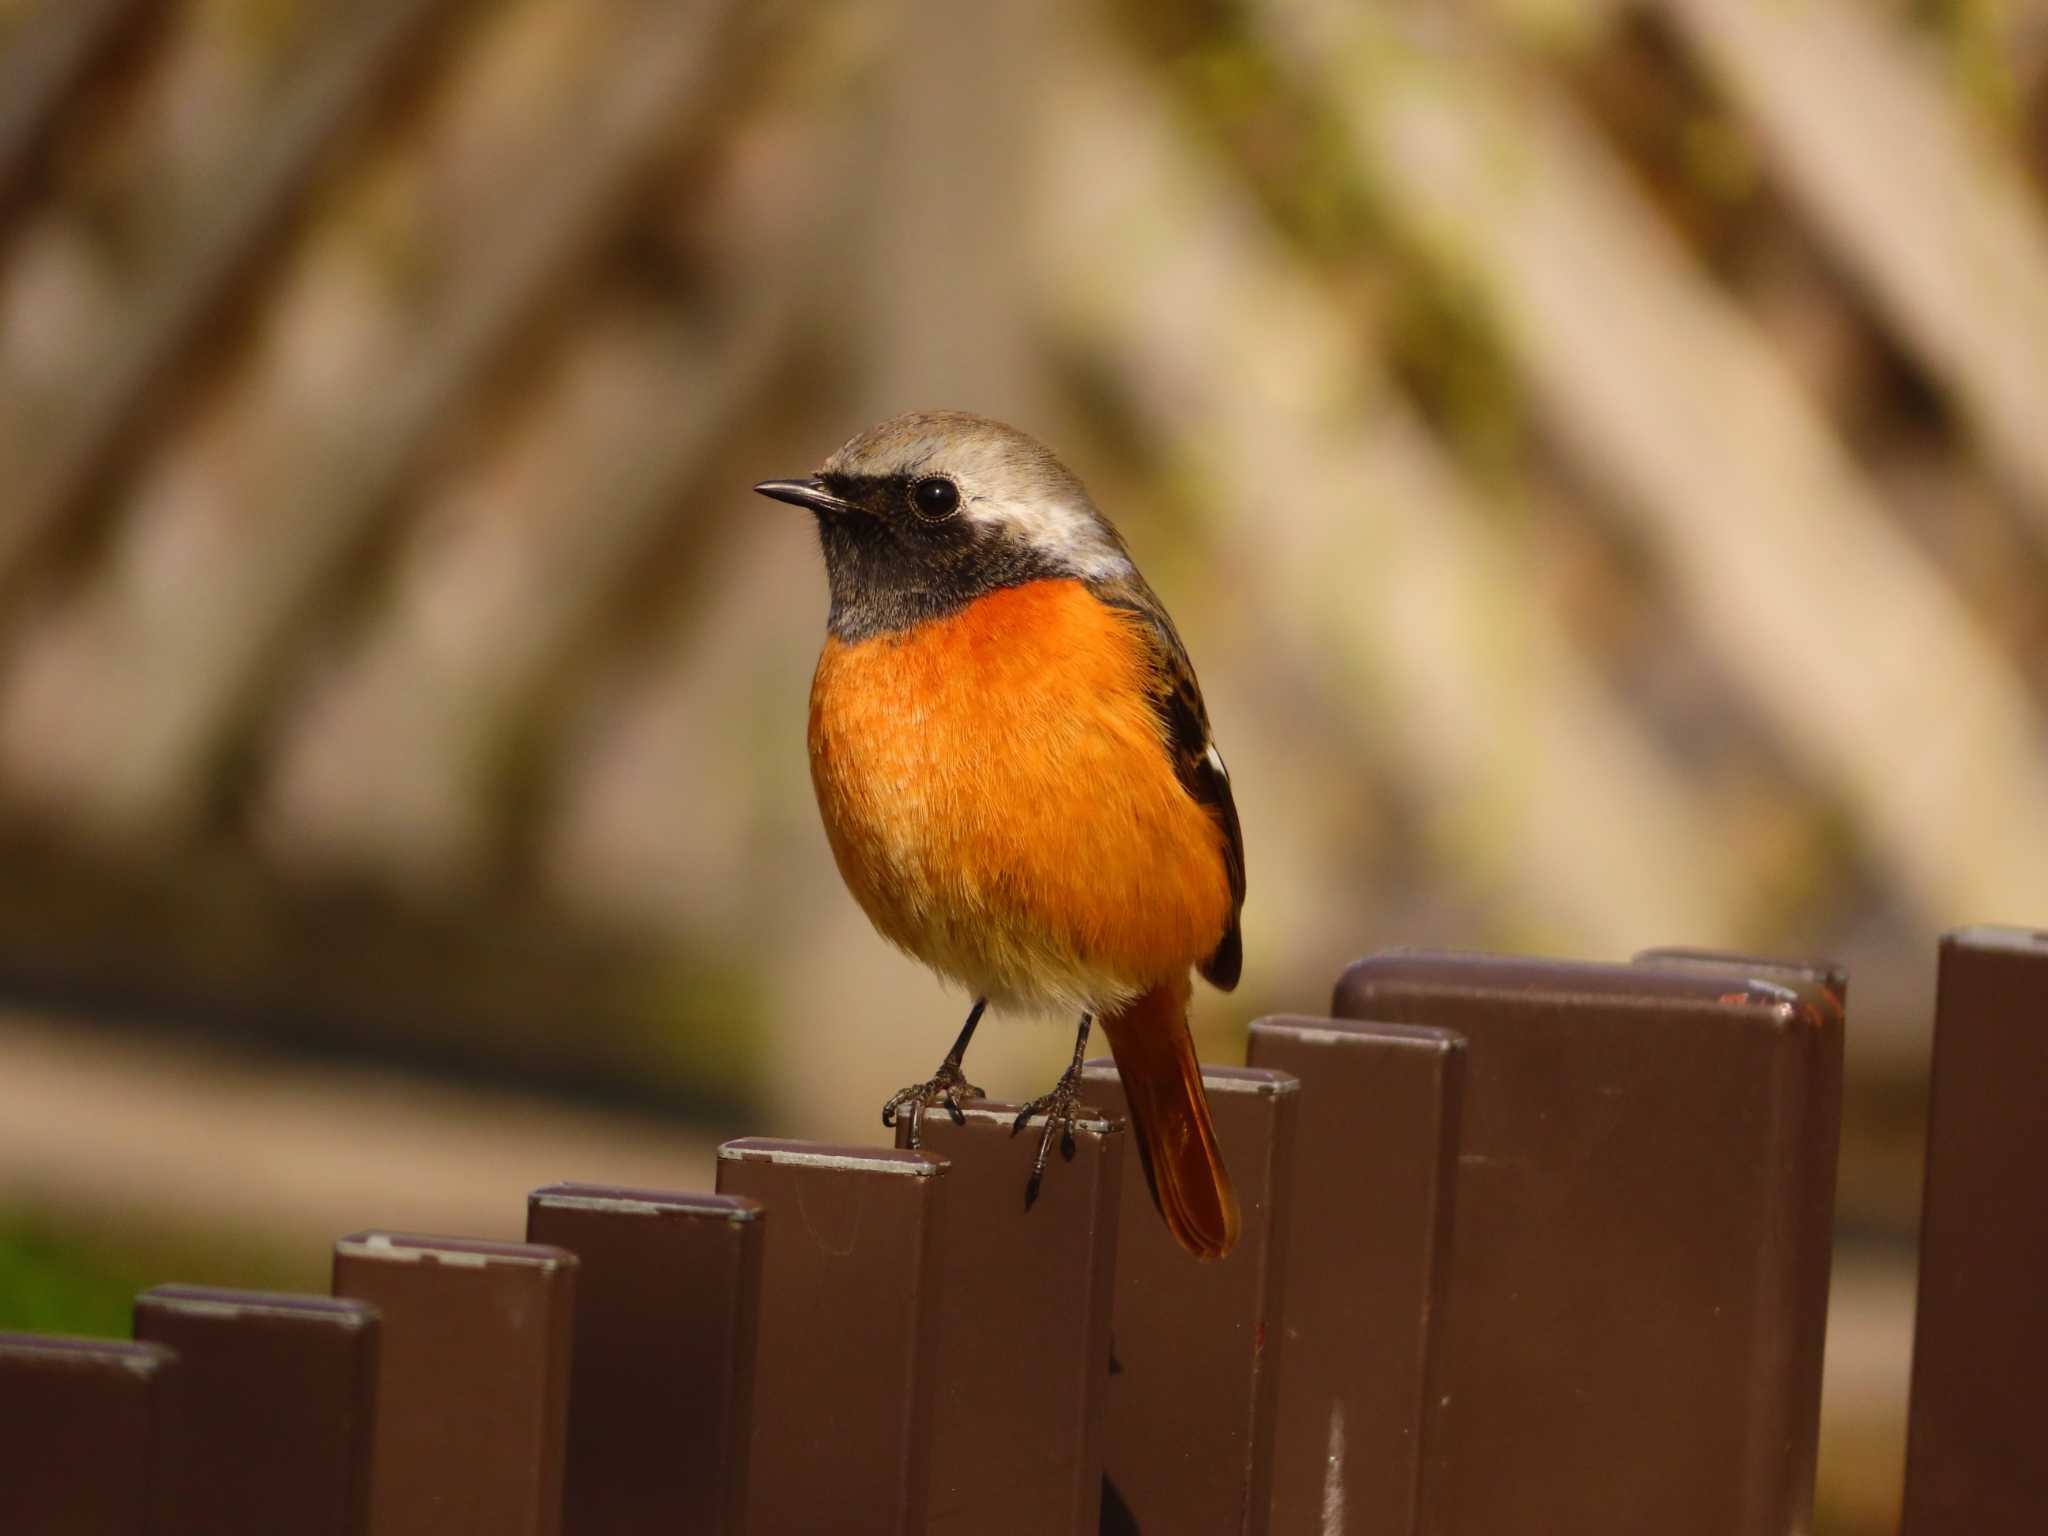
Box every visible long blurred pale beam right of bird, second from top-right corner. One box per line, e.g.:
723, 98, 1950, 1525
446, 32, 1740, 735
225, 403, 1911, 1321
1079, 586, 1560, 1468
1253, 0, 2048, 922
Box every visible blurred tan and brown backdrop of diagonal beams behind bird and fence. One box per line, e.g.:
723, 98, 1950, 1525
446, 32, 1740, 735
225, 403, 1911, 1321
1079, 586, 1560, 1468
0, 0, 2048, 1536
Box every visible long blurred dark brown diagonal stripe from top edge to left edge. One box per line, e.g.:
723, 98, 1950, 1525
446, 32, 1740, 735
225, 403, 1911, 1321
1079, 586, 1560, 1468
0, 0, 469, 592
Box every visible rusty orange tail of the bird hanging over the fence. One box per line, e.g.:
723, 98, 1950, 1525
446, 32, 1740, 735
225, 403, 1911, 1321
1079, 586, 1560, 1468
1102, 977, 1237, 1260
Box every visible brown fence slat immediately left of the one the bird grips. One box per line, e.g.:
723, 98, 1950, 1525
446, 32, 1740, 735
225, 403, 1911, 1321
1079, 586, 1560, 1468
719, 1137, 948, 1536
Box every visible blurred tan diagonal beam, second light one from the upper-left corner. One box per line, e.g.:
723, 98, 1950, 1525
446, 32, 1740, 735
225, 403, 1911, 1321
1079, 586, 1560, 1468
18, 0, 762, 838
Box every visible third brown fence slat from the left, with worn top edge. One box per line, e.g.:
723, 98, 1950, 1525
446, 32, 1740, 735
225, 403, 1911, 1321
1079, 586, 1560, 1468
334, 1231, 575, 1536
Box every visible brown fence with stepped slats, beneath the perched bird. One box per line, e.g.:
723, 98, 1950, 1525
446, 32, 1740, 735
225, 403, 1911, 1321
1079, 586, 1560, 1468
0, 928, 2048, 1536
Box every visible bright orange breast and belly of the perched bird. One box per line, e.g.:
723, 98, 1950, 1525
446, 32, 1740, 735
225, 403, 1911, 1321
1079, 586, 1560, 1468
811, 580, 1231, 1012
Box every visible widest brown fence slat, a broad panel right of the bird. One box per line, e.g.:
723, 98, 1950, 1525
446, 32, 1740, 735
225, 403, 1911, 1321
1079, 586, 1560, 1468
1333, 952, 1841, 1536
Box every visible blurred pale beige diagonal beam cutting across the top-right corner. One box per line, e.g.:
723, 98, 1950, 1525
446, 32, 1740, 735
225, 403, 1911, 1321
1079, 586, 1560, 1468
1661, 0, 2048, 535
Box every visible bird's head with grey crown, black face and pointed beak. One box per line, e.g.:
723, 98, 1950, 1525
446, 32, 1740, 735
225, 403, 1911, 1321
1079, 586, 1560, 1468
754, 412, 1133, 641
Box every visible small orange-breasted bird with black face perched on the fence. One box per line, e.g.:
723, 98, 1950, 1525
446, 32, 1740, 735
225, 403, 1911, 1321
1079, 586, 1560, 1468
754, 410, 1245, 1257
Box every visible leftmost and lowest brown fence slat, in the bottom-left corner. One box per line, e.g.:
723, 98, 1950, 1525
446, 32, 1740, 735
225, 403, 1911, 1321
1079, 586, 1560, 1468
0, 1333, 178, 1536
